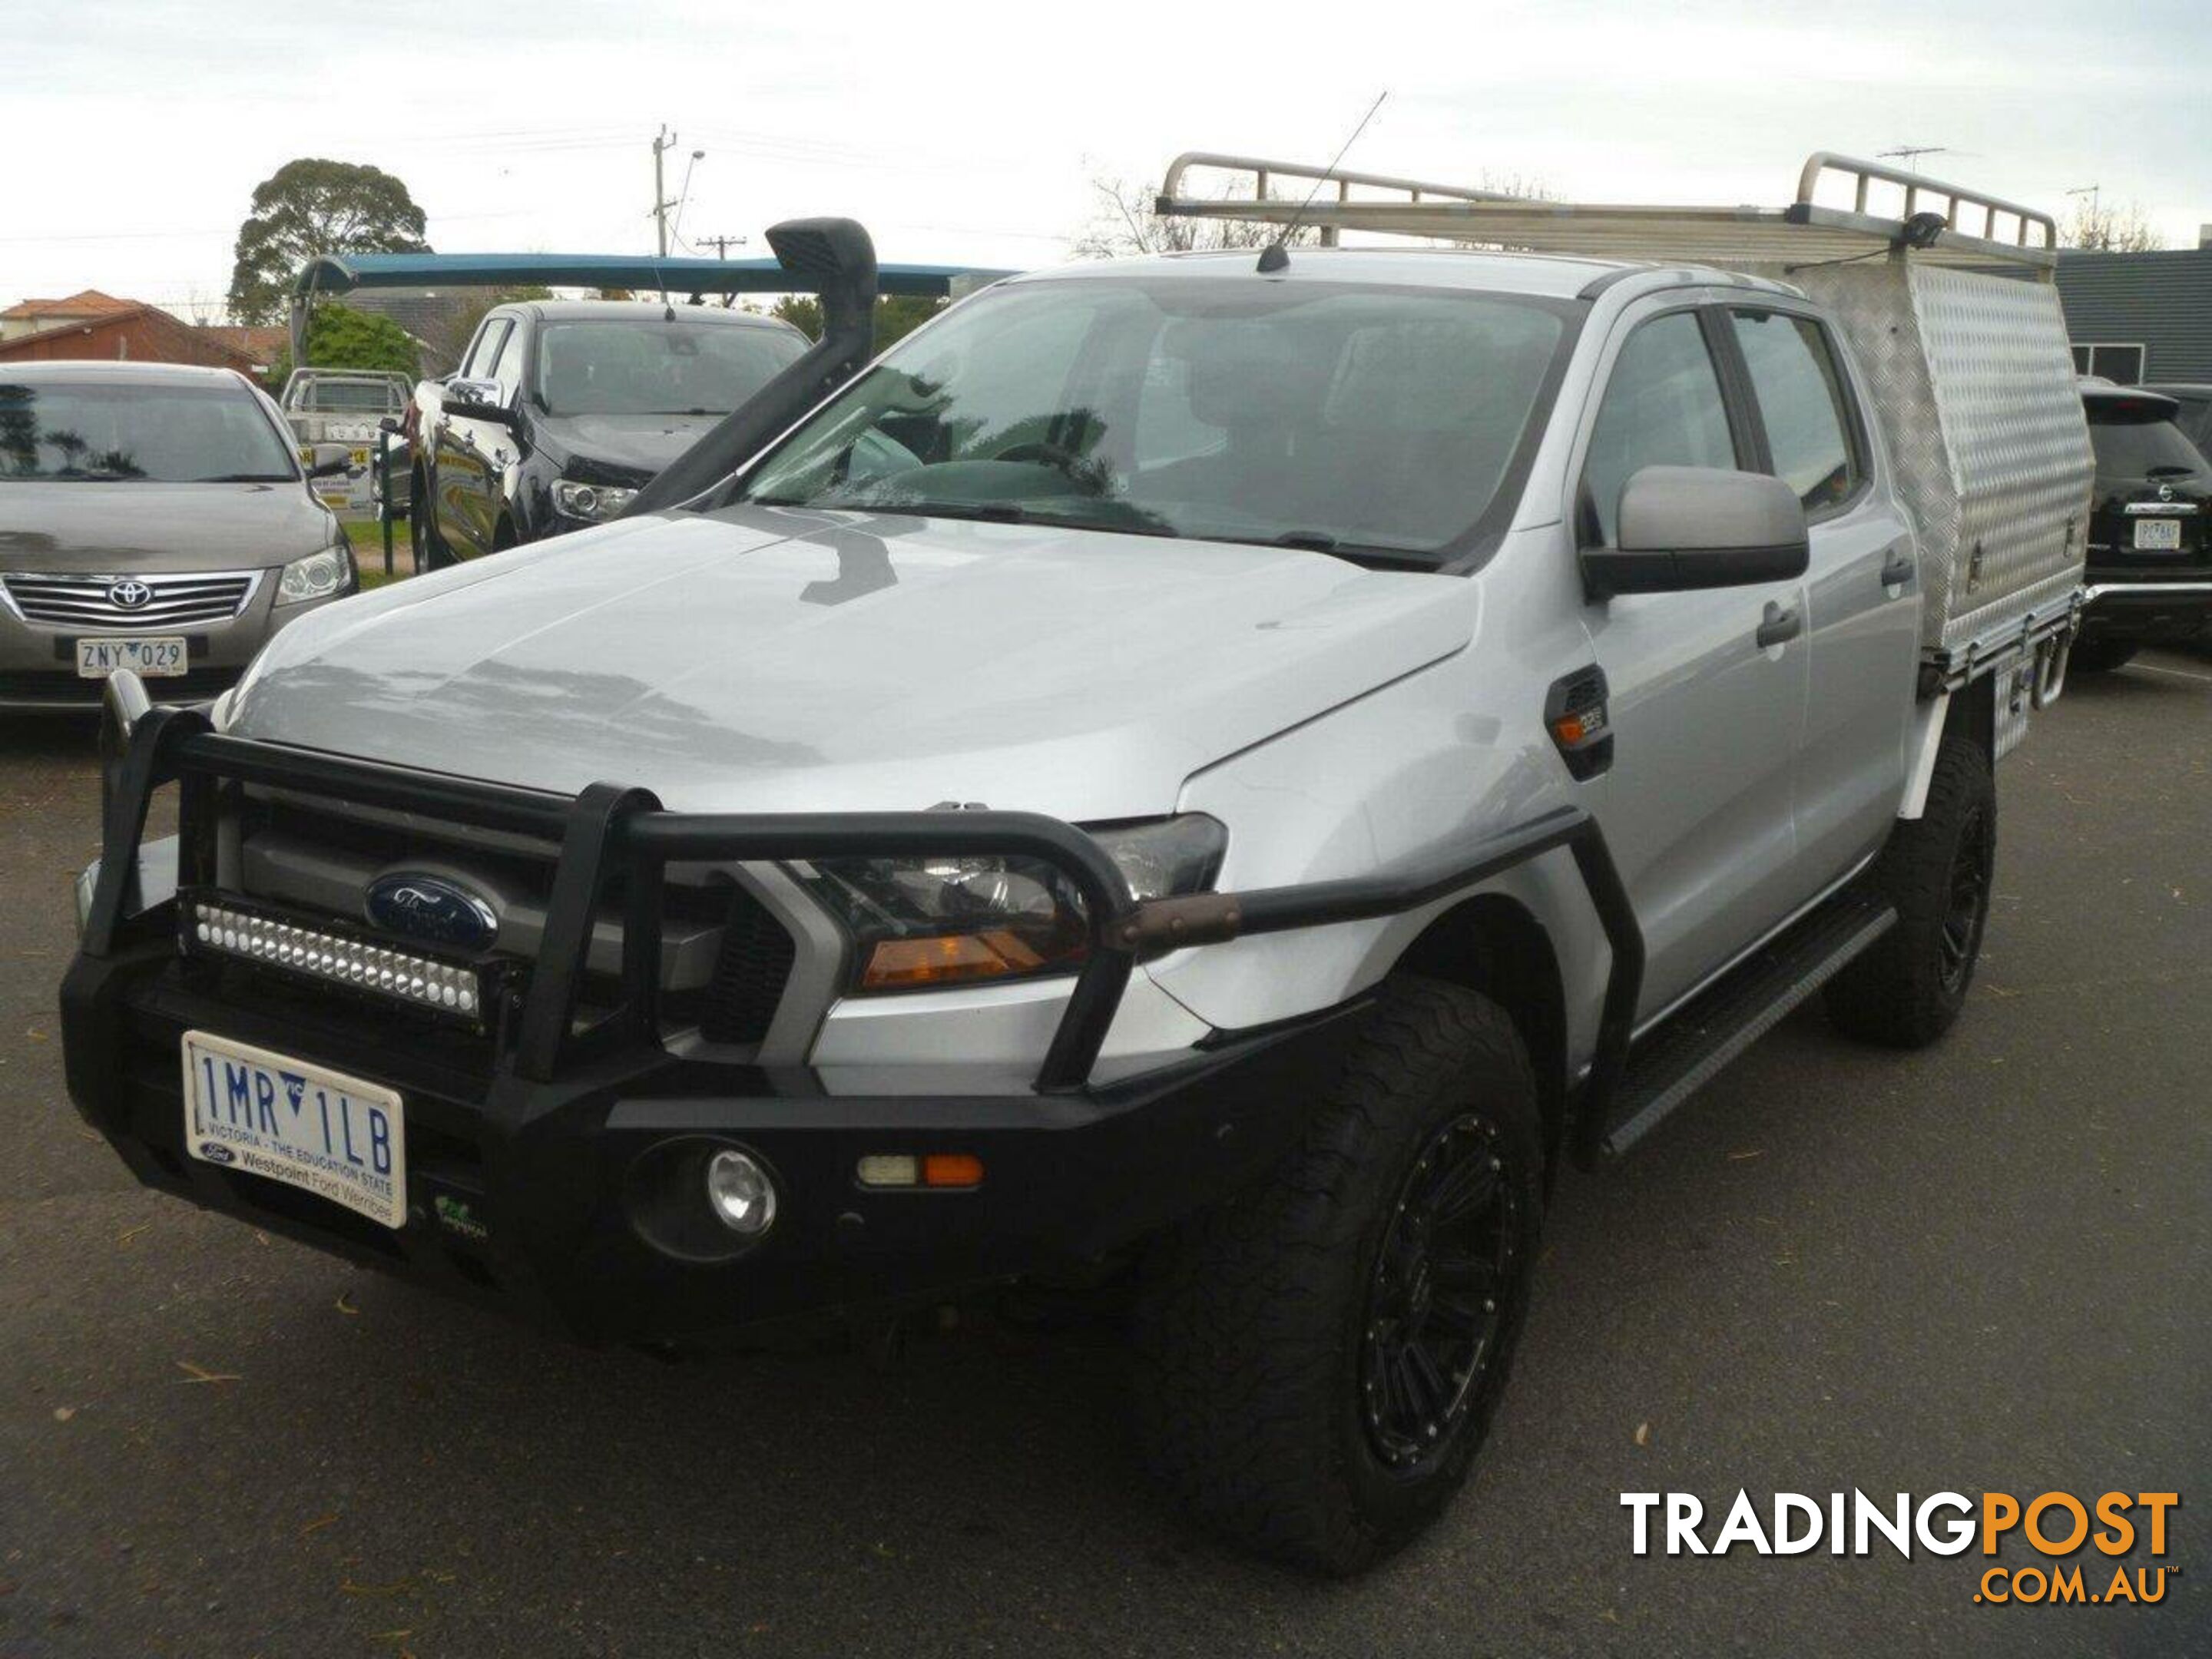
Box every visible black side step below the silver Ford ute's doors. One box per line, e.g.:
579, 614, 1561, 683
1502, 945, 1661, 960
1604, 889, 1898, 1157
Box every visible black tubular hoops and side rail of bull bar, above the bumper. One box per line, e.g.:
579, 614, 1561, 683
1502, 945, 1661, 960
80, 708, 1644, 1164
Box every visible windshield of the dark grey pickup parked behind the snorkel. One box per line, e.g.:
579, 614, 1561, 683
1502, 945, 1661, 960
531, 312, 807, 416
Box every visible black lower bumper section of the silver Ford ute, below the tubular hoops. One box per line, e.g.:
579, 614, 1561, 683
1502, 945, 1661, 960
62, 938, 1358, 1343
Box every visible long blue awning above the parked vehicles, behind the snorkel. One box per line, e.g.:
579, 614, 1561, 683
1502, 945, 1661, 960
292, 254, 1013, 299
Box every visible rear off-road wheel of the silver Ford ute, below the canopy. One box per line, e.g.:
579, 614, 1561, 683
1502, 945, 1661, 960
1823, 737, 1998, 1048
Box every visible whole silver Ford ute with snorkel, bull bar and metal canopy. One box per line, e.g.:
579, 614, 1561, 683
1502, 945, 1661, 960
65, 155, 2091, 1573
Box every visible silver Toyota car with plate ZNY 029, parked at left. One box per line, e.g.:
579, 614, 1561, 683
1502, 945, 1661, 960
0, 363, 359, 710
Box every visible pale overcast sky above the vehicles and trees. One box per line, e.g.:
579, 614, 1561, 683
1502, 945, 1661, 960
0, 0, 2212, 314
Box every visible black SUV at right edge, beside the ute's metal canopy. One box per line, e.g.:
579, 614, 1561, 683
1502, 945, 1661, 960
2073, 380, 2212, 673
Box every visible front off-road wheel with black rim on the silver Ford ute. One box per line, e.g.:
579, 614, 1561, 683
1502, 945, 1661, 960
1131, 975, 1544, 1575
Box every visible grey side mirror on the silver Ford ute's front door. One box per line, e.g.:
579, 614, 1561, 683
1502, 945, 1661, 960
1581, 467, 1812, 599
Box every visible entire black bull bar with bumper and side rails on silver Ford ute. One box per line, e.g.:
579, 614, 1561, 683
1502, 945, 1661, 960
62, 703, 1644, 1340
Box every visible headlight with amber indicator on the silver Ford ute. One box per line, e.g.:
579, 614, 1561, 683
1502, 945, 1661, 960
794, 812, 1227, 991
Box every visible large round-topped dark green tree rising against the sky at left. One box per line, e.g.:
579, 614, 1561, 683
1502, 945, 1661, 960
230, 157, 429, 323
